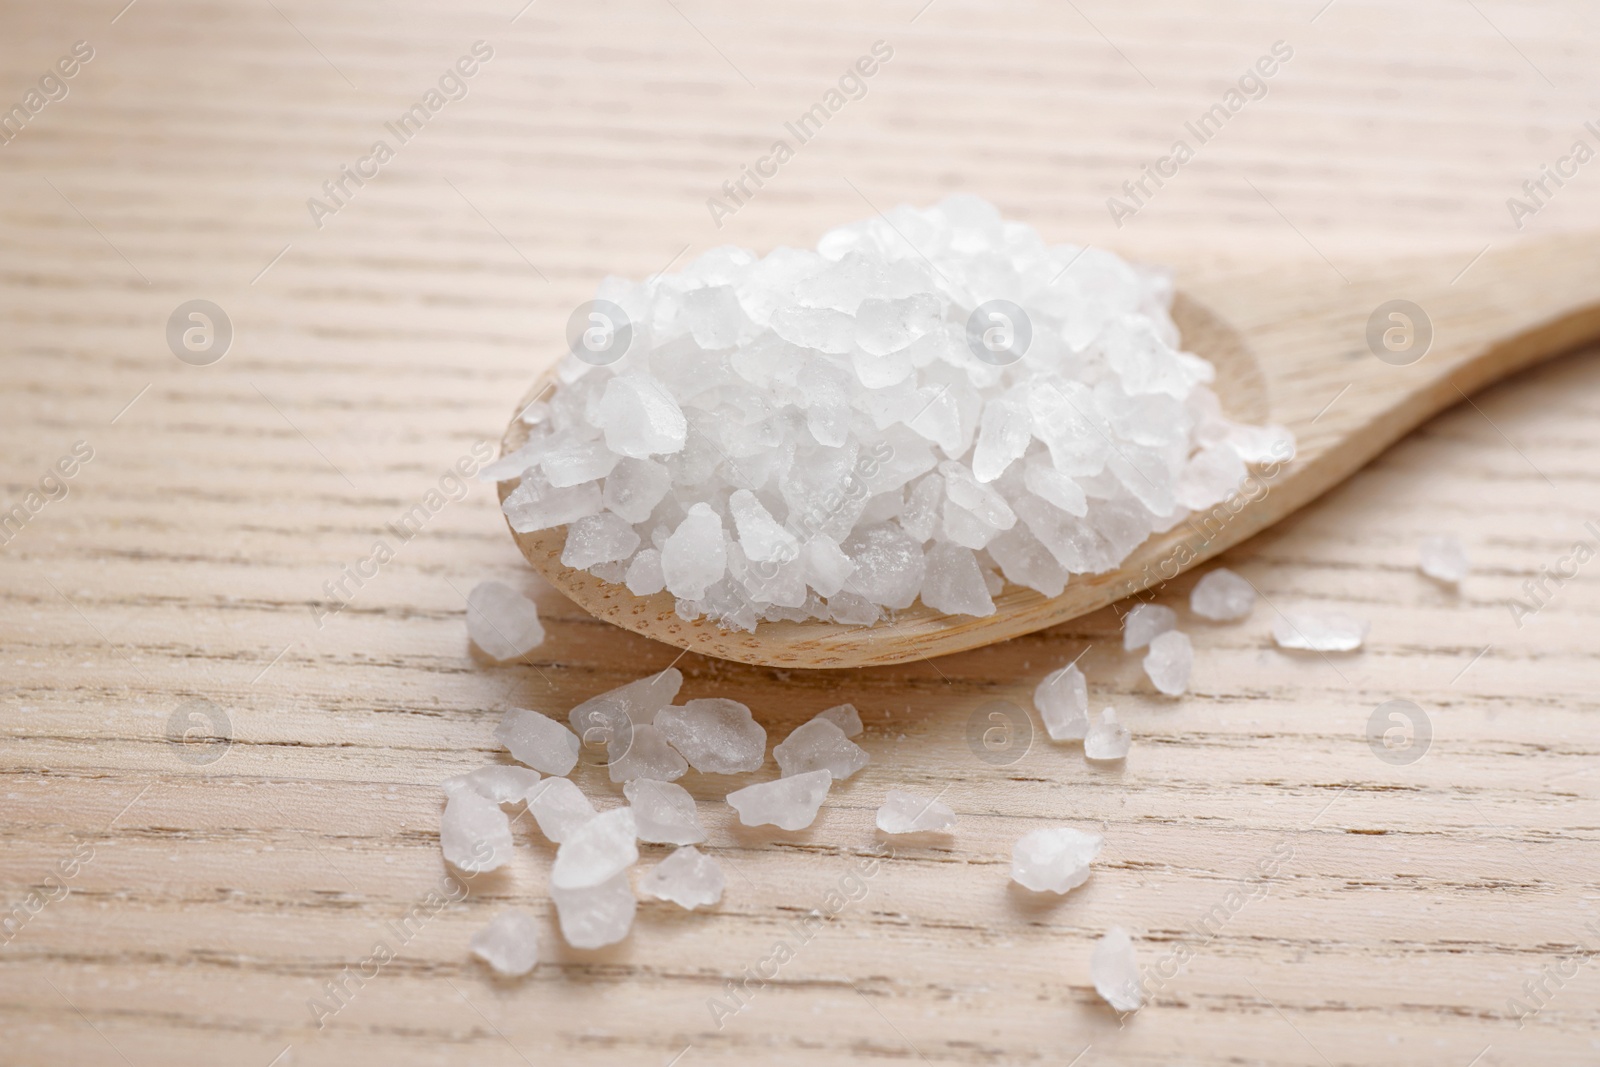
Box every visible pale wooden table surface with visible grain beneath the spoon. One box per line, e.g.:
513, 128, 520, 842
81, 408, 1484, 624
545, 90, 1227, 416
0, 0, 1600, 1067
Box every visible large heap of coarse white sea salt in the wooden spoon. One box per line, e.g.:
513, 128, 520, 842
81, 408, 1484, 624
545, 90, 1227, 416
482, 195, 1293, 630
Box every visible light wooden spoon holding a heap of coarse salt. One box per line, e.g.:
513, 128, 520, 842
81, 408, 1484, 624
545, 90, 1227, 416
499, 237, 1600, 669
